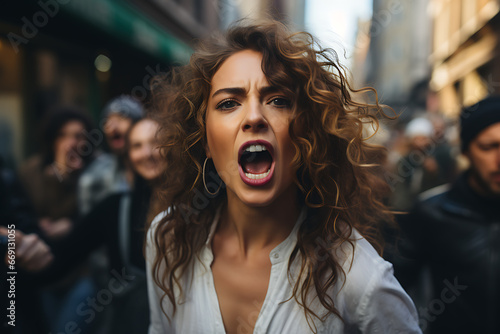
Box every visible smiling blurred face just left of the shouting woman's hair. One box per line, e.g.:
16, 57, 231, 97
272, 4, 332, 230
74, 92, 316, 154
129, 119, 165, 180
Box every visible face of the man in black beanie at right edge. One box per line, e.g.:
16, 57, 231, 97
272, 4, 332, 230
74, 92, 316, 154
465, 123, 500, 197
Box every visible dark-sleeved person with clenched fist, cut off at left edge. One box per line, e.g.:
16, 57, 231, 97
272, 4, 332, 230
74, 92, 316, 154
0, 157, 53, 333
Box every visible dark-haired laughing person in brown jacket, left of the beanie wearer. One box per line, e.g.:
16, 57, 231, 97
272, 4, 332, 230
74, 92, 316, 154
19, 107, 95, 333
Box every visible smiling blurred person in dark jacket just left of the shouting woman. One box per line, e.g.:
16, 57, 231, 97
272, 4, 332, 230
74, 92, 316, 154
44, 118, 166, 334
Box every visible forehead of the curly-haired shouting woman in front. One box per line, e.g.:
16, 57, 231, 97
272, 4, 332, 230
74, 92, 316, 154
212, 50, 267, 91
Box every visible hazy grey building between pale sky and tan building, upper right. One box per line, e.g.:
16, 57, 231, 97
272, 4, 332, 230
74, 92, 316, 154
353, 0, 432, 122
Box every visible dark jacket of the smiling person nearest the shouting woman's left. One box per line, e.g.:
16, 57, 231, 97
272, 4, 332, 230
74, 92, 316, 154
35, 177, 151, 333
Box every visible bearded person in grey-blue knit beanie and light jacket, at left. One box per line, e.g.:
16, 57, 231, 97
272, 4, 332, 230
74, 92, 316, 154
78, 95, 144, 215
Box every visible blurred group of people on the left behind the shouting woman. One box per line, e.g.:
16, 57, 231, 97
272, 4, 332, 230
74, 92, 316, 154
0, 96, 166, 333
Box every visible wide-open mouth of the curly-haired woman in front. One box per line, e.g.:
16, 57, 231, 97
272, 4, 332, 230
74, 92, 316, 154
238, 141, 274, 185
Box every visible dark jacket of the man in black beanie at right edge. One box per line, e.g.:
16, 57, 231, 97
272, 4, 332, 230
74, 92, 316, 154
394, 173, 500, 334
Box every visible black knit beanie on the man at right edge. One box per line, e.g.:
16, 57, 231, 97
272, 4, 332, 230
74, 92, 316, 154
460, 95, 500, 152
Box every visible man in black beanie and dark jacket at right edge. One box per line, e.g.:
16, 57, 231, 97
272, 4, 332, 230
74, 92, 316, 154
394, 96, 500, 334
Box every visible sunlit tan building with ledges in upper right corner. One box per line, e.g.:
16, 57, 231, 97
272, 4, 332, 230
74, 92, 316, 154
431, 0, 500, 118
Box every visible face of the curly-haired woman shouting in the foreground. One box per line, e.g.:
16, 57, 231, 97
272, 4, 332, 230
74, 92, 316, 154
206, 50, 297, 206
